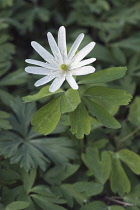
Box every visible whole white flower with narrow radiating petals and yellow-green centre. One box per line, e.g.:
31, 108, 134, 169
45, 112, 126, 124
25, 26, 96, 92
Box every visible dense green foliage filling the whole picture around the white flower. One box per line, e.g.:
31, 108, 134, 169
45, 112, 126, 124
0, 0, 140, 210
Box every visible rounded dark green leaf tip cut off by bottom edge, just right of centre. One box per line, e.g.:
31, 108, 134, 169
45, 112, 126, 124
80, 201, 107, 210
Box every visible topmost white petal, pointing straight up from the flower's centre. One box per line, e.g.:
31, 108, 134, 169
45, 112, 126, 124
58, 26, 67, 63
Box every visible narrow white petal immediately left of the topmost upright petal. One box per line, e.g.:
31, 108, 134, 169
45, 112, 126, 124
47, 32, 63, 64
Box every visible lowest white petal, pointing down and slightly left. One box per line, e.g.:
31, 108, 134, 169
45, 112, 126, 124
49, 75, 65, 92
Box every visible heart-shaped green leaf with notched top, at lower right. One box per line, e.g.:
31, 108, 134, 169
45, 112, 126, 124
82, 147, 111, 184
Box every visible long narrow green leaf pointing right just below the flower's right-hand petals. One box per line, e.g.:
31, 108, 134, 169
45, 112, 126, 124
79, 67, 127, 84
